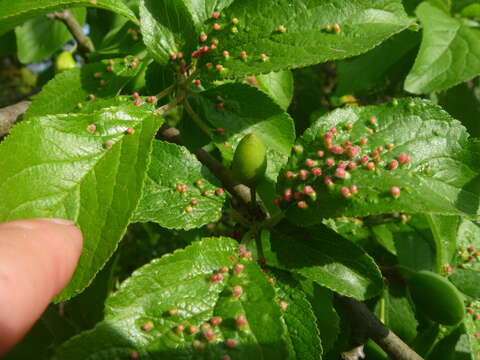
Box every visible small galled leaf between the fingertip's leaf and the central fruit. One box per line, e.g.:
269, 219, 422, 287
132, 141, 225, 230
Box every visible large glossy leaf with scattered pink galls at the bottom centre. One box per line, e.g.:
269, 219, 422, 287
56, 238, 288, 360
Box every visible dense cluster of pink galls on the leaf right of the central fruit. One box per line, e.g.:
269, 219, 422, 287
274, 117, 411, 209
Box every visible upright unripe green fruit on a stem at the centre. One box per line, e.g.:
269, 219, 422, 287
232, 134, 267, 186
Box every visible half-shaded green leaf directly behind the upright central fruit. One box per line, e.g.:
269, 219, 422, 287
188, 84, 295, 181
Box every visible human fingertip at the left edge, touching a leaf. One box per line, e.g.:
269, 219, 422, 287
0, 219, 83, 357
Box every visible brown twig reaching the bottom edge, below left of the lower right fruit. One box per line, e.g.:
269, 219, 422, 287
335, 294, 423, 360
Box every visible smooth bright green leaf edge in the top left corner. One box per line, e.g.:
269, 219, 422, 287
0, 0, 138, 35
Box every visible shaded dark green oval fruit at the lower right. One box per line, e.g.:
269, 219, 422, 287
410, 270, 465, 325
